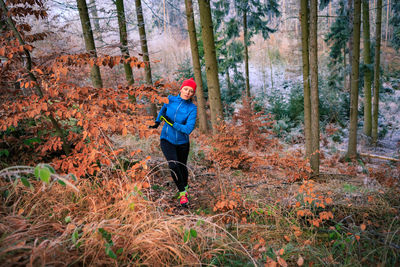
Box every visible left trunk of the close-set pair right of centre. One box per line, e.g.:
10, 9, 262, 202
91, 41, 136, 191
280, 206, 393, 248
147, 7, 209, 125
300, 0, 312, 159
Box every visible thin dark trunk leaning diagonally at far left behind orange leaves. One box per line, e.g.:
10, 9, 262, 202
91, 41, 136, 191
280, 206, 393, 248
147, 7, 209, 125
0, 0, 71, 155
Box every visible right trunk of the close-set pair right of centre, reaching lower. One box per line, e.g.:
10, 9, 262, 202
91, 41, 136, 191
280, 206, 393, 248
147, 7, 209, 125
310, 0, 319, 175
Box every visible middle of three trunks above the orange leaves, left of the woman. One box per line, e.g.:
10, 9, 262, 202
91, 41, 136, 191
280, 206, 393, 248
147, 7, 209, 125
115, 0, 135, 85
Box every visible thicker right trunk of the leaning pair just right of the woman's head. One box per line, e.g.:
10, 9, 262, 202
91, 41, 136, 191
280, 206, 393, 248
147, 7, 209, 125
199, 0, 224, 134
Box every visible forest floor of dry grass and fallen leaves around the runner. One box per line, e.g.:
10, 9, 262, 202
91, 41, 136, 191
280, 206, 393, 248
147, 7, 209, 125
0, 131, 400, 266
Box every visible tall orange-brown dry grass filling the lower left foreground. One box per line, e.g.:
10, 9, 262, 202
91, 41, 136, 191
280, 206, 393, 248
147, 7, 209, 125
0, 172, 255, 266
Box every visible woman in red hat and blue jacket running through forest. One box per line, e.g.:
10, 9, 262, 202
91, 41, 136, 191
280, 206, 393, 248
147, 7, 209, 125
149, 78, 197, 207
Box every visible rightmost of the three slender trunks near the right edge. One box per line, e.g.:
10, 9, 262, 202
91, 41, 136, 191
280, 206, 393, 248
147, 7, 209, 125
372, 0, 382, 143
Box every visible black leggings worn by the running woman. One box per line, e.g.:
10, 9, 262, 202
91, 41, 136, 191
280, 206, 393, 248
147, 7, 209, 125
161, 139, 190, 192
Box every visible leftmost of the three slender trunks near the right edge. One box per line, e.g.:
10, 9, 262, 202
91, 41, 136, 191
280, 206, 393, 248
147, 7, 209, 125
347, 0, 361, 158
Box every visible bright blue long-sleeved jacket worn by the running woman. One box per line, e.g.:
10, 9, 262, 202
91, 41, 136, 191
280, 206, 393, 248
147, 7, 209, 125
156, 95, 197, 145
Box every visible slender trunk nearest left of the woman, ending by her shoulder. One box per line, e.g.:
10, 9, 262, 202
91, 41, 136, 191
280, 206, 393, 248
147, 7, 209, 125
135, 0, 157, 118
